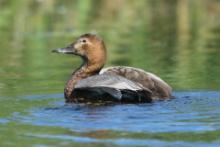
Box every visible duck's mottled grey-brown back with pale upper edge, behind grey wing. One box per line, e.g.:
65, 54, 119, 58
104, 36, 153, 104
100, 66, 172, 99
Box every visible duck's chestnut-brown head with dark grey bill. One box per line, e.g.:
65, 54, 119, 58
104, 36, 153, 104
52, 33, 106, 66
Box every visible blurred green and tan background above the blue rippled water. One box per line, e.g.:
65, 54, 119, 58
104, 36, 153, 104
0, 0, 220, 93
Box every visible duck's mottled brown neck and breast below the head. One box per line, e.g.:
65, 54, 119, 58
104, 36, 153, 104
64, 60, 103, 102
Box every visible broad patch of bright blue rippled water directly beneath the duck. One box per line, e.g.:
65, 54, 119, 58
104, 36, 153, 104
16, 92, 220, 133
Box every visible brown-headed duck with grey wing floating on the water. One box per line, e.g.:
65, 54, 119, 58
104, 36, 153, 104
52, 33, 172, 103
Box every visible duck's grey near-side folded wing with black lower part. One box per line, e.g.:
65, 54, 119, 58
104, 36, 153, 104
72, 74, 152, 103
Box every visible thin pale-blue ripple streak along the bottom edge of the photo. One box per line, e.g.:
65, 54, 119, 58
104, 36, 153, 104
26, 134, 220, 147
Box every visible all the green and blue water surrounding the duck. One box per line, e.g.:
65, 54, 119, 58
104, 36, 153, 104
0, 0, 220, 147
